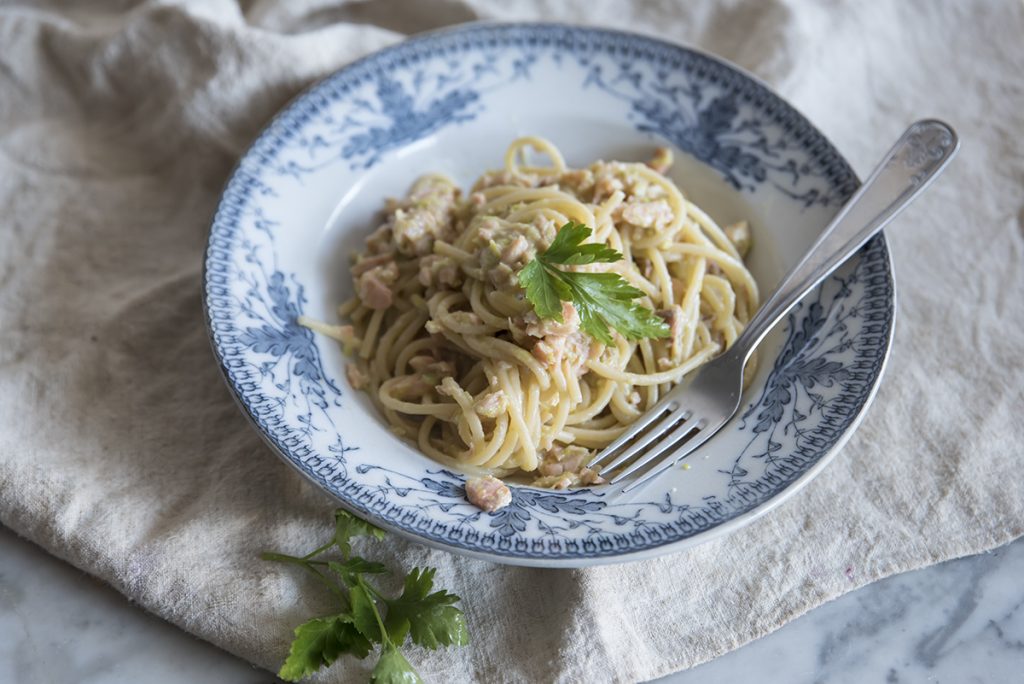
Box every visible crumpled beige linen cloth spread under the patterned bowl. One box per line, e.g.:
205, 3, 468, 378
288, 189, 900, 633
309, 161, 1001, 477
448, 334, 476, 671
0, 0, 1024, 682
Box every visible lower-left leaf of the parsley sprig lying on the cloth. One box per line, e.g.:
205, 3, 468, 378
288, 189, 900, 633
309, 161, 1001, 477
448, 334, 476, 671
278, 615, 372, 682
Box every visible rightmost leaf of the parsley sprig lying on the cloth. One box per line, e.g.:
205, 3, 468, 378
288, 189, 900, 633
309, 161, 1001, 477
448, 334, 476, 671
384, 567, 469, 648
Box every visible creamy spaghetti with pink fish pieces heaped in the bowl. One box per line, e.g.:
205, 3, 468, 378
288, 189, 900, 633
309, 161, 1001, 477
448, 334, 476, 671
301, 137, 758, 488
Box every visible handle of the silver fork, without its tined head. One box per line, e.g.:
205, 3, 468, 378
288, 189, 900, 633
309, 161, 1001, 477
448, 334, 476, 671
729, 119, 959, 359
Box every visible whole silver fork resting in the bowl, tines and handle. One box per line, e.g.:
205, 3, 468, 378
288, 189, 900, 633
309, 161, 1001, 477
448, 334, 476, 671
590, 120, 959, 491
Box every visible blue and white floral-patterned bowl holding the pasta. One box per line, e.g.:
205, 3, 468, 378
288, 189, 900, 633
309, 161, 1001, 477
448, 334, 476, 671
205, 25, 894, 566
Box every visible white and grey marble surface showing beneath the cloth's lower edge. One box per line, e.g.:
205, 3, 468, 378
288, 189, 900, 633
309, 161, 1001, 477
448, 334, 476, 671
0, 527, 1024, 684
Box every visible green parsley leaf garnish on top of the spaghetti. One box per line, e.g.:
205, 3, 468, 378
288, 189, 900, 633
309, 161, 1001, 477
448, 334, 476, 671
519, 221, 669, 344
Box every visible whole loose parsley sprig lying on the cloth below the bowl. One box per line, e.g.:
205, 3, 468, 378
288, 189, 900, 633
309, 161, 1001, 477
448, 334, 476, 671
262, 509, 469, 684
